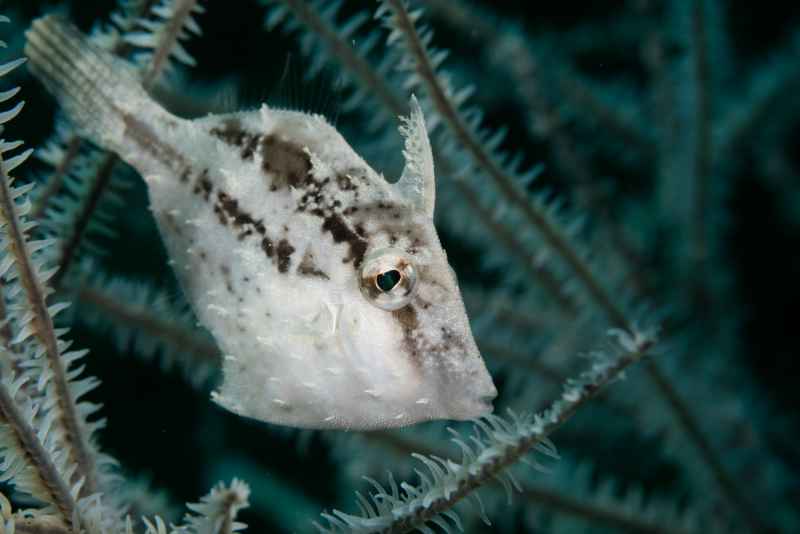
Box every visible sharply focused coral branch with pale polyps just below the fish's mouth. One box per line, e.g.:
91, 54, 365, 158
318, 331, 655, 533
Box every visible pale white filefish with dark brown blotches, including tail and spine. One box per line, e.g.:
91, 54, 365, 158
26, 16, 496, 429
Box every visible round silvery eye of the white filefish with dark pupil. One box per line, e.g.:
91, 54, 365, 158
360, 250, 417, 311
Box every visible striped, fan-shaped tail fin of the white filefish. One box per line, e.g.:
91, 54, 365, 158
25, 15, 160, 151
